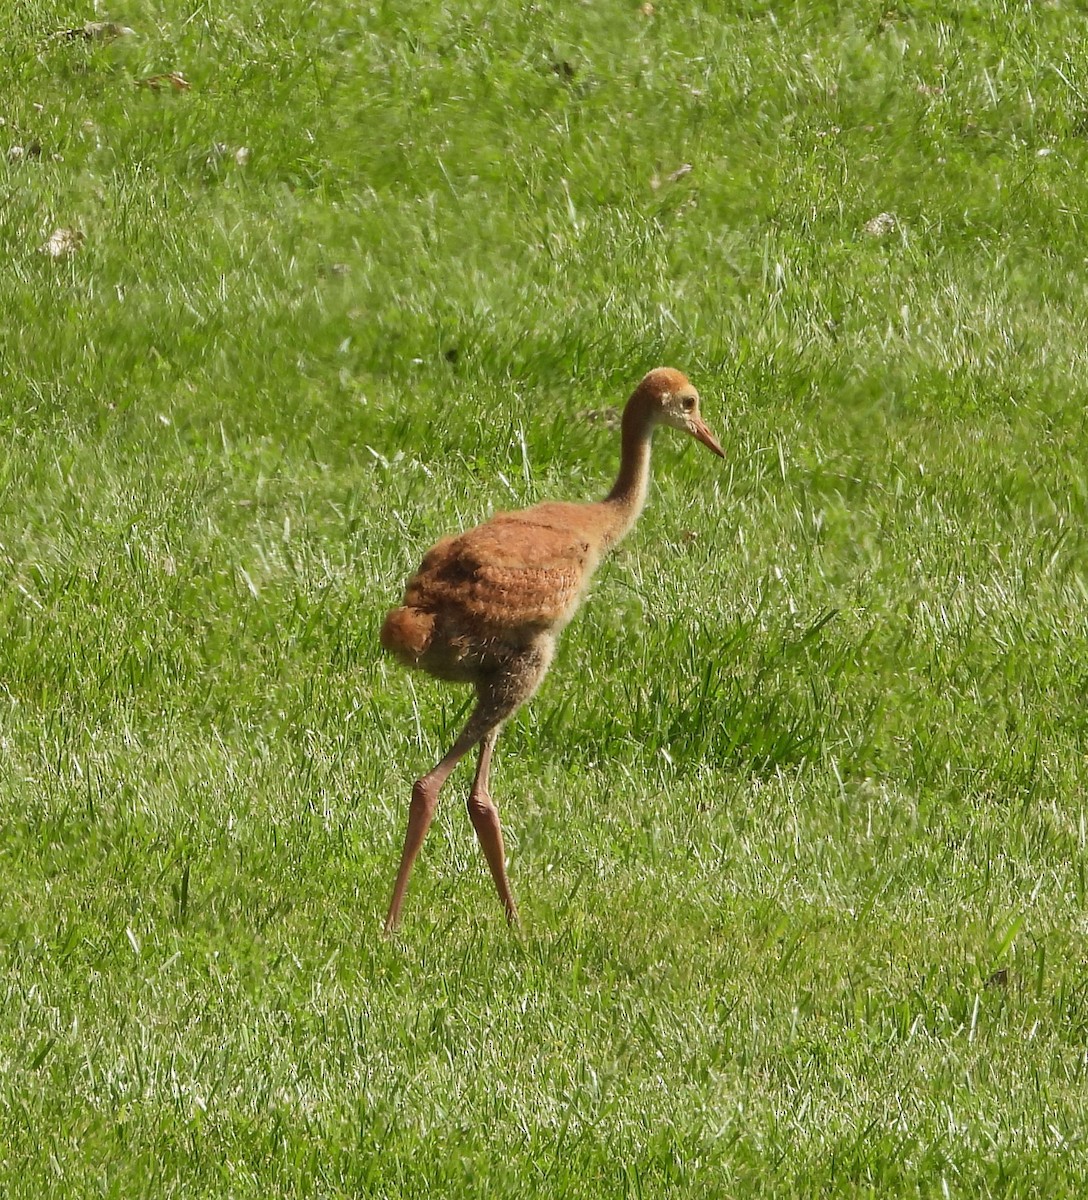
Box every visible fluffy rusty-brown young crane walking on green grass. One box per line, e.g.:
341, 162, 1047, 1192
381, 367, 725, 932
